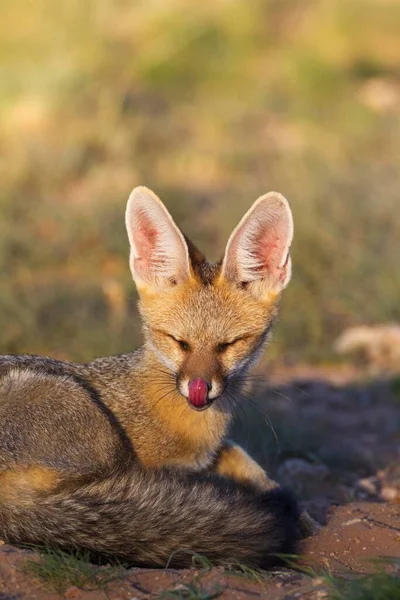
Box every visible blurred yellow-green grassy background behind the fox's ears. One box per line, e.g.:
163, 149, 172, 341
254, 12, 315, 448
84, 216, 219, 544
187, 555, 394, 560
0, 0, 400, 361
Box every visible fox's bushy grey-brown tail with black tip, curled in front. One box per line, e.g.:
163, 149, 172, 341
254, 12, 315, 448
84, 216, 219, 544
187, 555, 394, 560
0, 469, 298, 568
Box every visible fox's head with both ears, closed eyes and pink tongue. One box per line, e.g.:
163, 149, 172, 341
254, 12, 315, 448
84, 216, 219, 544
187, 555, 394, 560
126, 187, 293, 410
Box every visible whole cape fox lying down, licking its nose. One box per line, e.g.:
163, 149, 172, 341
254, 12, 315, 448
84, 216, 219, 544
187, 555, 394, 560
0, 187, 299, 567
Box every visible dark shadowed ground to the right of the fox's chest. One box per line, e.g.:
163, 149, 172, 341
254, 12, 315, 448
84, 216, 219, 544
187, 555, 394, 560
232, 374, 400, 522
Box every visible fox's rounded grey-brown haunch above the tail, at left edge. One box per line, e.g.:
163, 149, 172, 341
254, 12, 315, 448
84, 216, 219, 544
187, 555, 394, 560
0, 356, 132, 475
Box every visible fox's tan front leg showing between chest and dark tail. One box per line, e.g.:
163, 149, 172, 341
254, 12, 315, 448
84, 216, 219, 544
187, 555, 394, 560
214, 440, 321, 537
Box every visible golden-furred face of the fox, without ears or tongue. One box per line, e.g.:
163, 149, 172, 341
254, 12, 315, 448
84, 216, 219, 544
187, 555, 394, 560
140, 252, 278, 408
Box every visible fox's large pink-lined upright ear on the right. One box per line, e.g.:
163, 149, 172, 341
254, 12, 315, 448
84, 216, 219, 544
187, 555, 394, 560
222, 192, 293, 297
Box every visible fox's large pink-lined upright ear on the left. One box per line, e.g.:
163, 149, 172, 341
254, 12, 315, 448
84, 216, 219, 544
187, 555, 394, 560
126, 187, 190, 291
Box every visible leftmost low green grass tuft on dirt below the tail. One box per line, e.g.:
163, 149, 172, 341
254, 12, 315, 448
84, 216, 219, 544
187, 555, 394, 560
23, 549, 123, 594
